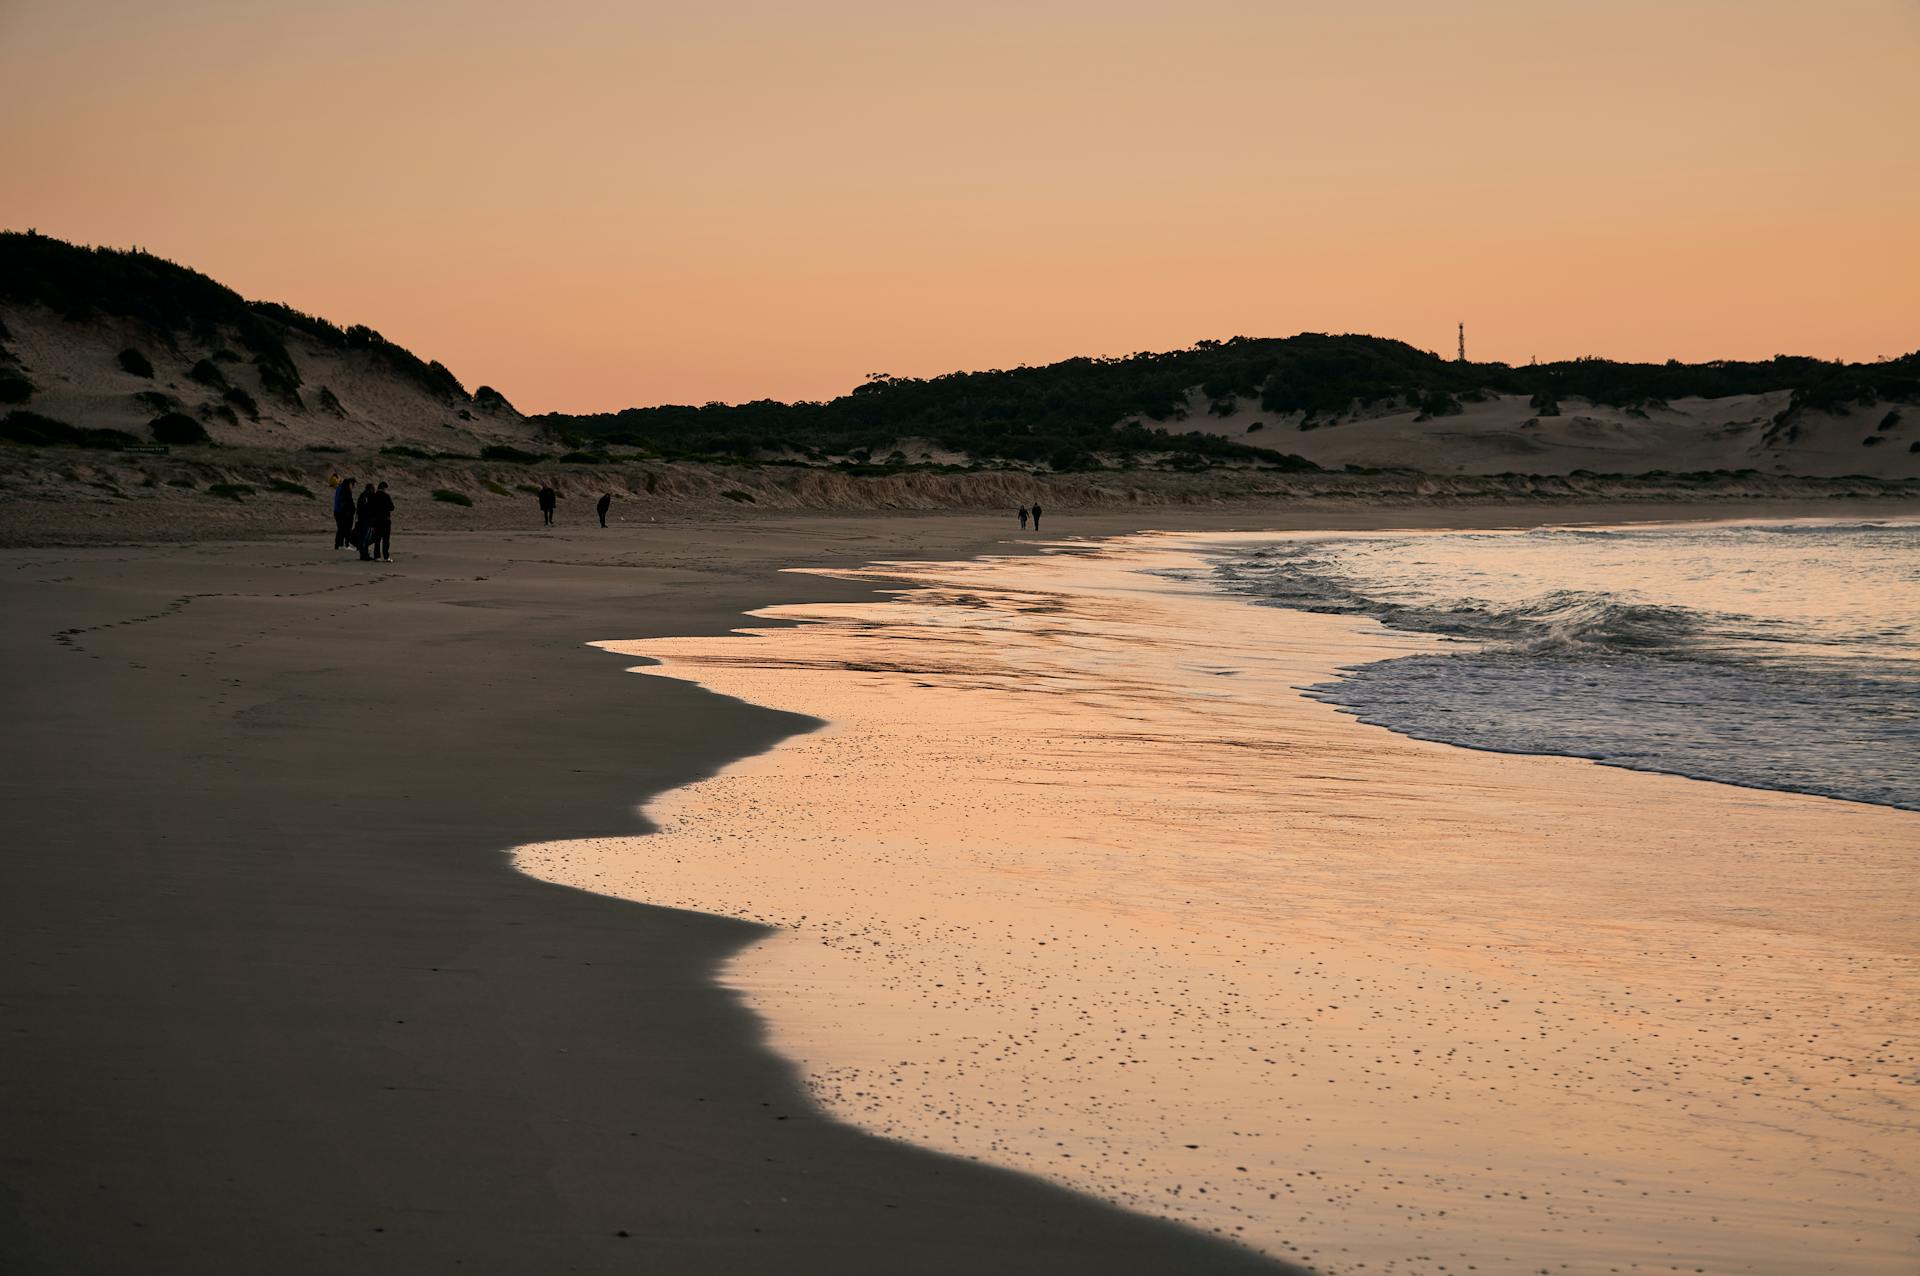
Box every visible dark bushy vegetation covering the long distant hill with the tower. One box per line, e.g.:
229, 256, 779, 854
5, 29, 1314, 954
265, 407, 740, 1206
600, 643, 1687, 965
534, 334, 1920, 472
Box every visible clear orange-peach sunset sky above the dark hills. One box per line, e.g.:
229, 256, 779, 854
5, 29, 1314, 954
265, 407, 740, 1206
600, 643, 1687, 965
0, 0, 1920, 411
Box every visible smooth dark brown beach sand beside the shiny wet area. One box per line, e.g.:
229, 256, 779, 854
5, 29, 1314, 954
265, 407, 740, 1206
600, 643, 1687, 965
0, 505, 1912, 1272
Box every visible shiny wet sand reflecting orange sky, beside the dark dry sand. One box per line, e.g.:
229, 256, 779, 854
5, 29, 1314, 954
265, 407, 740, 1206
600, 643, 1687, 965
518, 537, 1920, 1274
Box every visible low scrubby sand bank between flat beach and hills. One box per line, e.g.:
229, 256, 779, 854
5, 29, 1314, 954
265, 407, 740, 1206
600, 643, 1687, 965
0, 462, 1920, 549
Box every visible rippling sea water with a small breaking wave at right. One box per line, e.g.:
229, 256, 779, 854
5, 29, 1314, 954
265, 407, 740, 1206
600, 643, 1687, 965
1213, 522, 1920, 810
